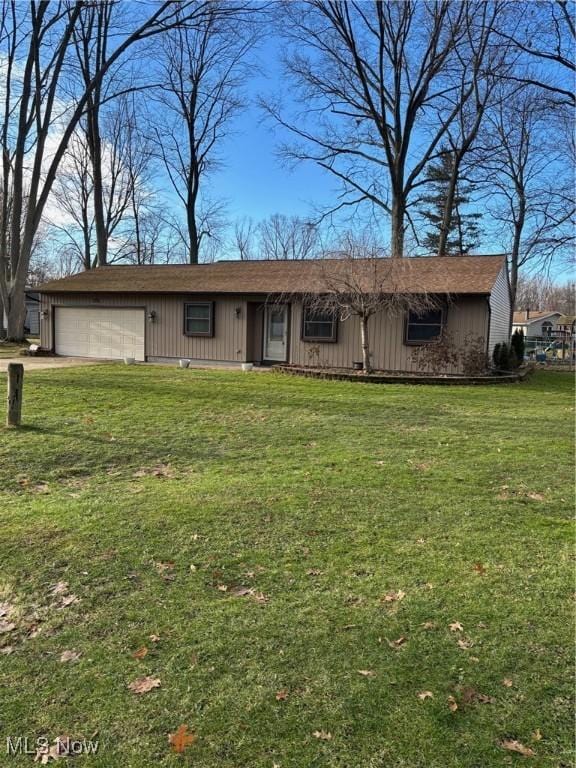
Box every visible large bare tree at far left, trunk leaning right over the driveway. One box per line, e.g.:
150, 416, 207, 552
0, 0, 224, 340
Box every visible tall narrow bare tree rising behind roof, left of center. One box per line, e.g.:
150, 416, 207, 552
155, 2, 255, 264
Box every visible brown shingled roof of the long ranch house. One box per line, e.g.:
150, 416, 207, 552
39, 256, 505, 295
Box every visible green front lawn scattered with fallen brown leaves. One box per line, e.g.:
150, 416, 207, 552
0, 365, 573, 768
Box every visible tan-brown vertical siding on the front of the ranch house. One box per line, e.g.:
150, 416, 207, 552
41, 293, 490, 373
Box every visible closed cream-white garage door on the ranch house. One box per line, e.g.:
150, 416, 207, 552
54, 307, 144, 360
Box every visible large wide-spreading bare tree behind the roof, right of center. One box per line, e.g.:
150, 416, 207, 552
267, 0, 500, 258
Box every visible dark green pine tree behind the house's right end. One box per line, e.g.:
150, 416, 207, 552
419, 150, 482, 256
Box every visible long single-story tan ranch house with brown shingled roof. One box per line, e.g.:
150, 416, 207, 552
40, 256, 510, 371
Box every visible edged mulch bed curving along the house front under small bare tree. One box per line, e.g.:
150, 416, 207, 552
274, 365, 532, 384
